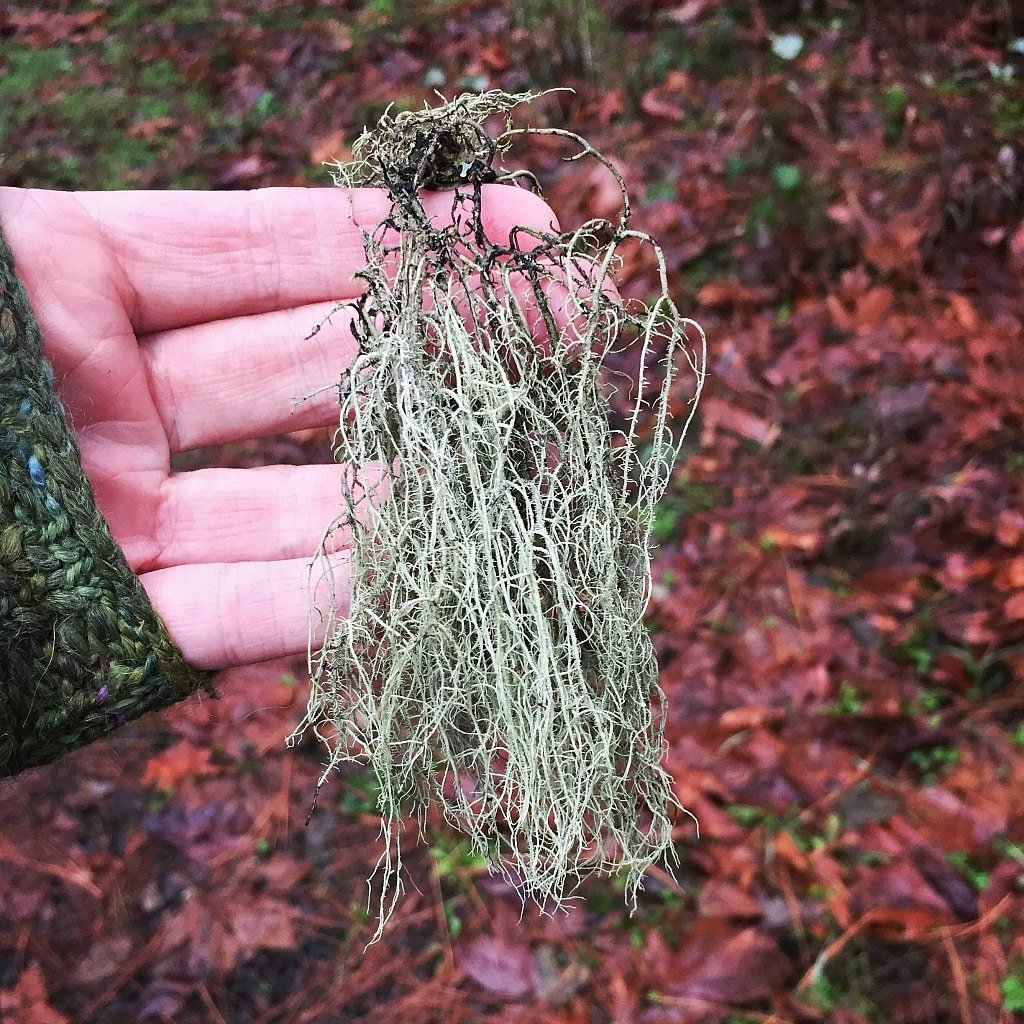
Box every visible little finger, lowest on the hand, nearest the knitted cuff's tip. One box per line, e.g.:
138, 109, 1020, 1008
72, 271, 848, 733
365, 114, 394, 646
139, 554, 348, 670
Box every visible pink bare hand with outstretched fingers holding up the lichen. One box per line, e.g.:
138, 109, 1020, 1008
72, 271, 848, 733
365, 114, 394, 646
0, 185, 554, 669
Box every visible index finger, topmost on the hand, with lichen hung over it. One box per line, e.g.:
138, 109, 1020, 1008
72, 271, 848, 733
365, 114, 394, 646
76, 185, 554, 334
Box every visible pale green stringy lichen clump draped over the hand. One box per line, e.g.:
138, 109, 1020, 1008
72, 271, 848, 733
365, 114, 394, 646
300, 92, 705, 935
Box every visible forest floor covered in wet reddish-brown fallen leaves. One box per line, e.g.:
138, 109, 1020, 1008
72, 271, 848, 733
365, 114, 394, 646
0, 0, 1024, 1024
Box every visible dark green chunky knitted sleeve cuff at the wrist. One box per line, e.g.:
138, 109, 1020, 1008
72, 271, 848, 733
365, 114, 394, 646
0, 218, 212, 775
